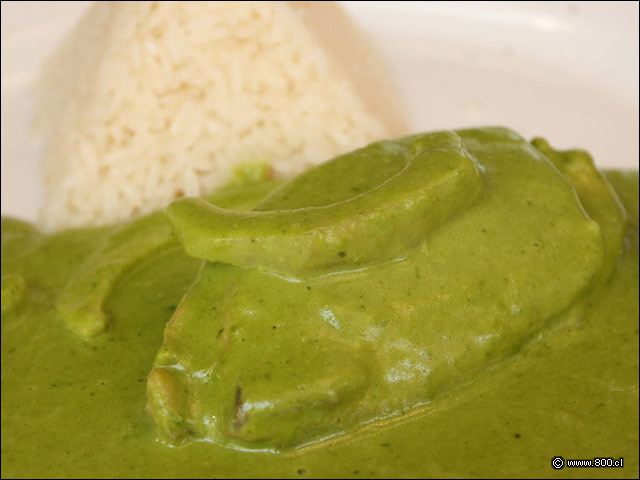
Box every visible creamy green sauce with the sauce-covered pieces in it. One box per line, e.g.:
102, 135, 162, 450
0, 129, 638, 478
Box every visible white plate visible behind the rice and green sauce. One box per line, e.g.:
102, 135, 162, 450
1, 1, 638, 220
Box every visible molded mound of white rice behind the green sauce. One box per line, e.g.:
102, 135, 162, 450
36, 1, 406, 230
